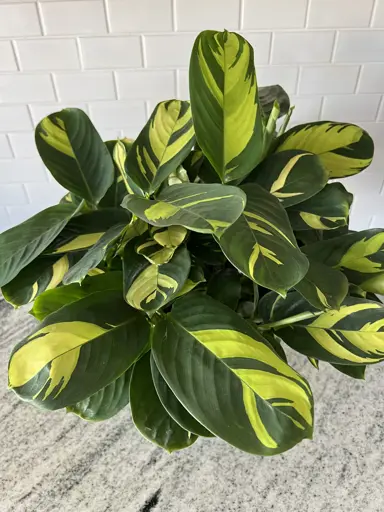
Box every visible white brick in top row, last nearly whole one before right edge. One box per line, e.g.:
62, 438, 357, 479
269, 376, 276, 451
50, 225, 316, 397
308, 0, 374, 28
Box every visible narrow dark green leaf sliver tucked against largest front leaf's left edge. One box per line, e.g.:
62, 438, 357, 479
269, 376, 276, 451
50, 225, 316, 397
151, 354, 213, 437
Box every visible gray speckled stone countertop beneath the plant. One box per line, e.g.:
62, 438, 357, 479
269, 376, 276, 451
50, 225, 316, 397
0, 302, 384, 512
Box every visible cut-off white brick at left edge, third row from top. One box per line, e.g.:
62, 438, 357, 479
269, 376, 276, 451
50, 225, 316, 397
0, 74, 55, 103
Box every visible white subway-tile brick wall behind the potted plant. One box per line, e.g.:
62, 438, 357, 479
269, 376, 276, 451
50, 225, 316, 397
0, 0, 384, 230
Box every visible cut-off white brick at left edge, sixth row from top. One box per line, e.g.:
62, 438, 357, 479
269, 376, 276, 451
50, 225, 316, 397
0, 159, 47, 184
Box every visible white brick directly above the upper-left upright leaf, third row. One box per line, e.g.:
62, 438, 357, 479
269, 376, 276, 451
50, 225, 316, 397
55, 71, 116, 101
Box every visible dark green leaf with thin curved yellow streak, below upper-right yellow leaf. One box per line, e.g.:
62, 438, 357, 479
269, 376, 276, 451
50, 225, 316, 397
246, 149, 328, 208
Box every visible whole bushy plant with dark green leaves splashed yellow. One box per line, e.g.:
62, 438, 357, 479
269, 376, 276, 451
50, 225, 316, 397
0, 31, 384, 455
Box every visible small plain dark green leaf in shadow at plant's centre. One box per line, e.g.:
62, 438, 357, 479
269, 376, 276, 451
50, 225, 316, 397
207, 268, 241, 311
